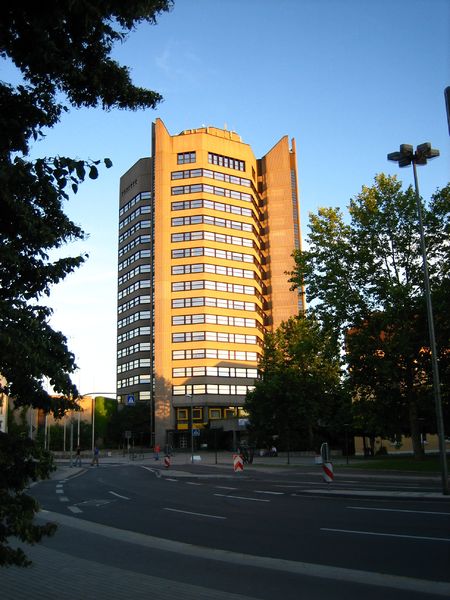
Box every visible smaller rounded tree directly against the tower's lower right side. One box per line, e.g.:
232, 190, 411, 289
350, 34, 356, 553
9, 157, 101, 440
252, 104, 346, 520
246, 315, 345, 449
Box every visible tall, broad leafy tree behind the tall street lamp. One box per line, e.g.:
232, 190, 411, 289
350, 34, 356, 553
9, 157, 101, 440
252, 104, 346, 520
291, 174, 450, 457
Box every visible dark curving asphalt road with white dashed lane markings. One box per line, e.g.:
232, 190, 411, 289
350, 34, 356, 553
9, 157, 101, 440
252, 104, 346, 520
23, 464, 450, 600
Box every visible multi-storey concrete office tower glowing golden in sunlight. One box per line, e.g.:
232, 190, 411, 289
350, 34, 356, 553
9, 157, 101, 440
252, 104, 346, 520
117, 119, 302, 447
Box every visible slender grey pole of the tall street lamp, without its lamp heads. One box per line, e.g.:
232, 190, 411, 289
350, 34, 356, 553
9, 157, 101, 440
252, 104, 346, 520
412, 159, 449, 496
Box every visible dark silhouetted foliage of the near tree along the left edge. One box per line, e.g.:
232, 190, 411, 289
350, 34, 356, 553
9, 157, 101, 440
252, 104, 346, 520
0, 0, 172, 565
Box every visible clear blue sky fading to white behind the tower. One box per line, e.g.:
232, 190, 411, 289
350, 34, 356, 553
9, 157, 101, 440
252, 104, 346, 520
0, 0, 450, 393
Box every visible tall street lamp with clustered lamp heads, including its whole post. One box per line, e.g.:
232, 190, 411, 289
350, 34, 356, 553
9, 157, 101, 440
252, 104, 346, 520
387, 142, 449, 496
